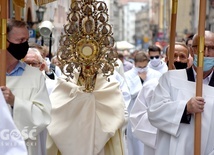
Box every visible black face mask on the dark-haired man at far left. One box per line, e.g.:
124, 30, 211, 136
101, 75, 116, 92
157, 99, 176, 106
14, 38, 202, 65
7, 40, 29, 60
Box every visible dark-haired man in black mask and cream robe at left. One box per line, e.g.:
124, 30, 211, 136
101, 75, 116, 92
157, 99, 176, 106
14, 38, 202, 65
0, 19, 51, 155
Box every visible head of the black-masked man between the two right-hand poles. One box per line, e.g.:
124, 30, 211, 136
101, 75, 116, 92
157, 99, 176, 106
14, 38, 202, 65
165, 42, 189, 69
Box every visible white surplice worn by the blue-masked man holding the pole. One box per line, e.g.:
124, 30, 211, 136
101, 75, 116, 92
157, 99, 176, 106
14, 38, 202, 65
148, 69, 214, 155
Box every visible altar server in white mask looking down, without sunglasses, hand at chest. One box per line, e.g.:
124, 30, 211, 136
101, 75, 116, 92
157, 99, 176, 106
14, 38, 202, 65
125, 52, 161, 155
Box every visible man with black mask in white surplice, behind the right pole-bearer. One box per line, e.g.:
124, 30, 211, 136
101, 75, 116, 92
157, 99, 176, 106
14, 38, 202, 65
129, 42, 189, 155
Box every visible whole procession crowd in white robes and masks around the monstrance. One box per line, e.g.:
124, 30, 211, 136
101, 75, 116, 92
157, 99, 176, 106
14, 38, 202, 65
0, 19, 214, 155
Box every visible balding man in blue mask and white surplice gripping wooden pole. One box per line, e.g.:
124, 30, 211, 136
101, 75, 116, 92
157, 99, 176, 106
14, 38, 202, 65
148, 31, 214, 155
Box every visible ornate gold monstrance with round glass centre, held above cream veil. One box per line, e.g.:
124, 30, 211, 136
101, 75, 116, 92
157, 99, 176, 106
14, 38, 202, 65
57, 0, 117, 92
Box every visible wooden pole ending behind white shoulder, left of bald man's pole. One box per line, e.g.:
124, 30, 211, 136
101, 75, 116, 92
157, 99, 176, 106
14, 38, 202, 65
168, 0, 178, 70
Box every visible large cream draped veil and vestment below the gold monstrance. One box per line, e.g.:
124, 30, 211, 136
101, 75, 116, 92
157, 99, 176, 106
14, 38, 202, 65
47, 74, 125, 155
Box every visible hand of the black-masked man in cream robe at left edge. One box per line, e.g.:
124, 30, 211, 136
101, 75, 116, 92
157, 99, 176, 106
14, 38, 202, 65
0, 86, 15, 107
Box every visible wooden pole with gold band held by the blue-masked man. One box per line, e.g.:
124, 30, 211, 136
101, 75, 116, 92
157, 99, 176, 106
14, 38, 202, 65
194, 0, 206, 155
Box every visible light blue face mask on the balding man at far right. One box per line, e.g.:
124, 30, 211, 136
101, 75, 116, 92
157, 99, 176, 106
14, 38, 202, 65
193, 54, 214, 72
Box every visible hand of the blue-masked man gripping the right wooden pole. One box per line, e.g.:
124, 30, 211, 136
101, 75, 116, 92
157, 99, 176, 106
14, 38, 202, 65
187, 96, 205, 114
